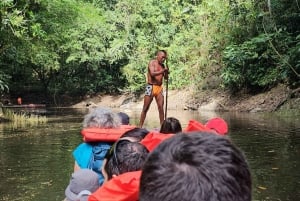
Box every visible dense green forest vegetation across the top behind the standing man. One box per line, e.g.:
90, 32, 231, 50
0, 0, 300, 102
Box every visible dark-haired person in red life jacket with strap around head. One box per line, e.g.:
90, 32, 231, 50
88, 137, 149, 201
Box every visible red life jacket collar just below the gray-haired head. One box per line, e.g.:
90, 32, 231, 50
81, 125, 136, 142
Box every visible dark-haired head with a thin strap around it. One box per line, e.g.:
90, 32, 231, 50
104, 139, 149, 179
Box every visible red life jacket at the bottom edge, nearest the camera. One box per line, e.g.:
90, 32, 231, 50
88, 171, 142, 201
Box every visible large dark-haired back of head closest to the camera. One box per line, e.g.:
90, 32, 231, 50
139, 132, 251, 201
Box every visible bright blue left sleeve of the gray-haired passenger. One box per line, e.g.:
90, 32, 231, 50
73, 143, 92, 168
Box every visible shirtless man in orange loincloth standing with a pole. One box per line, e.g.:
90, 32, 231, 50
139, 50, 168, 128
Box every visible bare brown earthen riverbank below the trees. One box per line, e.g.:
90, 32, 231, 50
71, 85, 300, 112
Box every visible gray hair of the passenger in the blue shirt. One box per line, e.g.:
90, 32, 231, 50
83, 107, 121, 128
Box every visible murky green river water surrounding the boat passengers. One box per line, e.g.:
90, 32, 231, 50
0, 109, 300, 201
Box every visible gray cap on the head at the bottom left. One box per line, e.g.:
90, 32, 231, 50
65, 169, 99, 201
